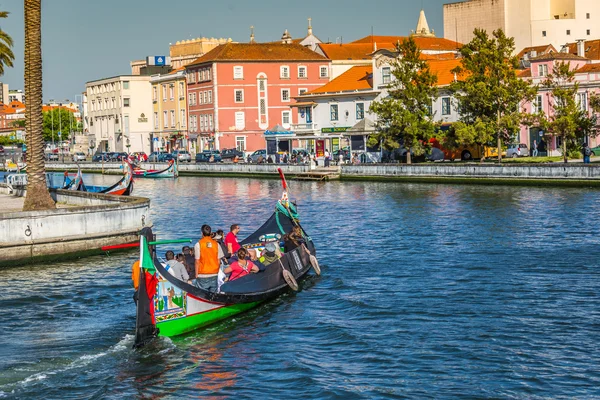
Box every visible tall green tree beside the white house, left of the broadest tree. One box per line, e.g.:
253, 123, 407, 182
369, 37, 438, 164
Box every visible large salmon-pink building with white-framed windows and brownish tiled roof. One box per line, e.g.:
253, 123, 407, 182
186, 43, 330, 152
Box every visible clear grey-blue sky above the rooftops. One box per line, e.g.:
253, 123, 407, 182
0, 0, 450, 102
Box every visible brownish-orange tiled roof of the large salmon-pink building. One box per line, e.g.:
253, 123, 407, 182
186, 43, 327, 68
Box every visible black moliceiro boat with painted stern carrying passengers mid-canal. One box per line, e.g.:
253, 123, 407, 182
134, 171, 320, 347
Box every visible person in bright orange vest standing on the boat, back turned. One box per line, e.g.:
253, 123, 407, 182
194, 225, 225, 291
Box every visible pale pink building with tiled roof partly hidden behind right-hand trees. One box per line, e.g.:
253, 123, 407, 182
519, 52, 600, 156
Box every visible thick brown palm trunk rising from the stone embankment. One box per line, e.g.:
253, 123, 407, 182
23, 0, 56, 211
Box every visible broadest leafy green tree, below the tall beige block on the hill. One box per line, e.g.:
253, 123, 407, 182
444, 29, 537, 161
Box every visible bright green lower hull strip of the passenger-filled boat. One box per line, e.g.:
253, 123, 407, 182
156, 301, 261, 337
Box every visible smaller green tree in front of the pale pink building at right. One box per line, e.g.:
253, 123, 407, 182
540, 62, 599, 163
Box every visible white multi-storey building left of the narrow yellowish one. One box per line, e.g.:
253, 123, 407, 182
84, 75, 152, 153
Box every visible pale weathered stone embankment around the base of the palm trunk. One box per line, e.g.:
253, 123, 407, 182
0, 184, 150, 266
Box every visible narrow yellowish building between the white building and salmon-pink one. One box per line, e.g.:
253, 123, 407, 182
150, 67, 190, 152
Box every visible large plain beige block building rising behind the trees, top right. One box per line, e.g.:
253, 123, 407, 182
444, 0, 600, 51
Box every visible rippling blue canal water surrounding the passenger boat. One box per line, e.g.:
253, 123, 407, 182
0, 176, 600, 399
